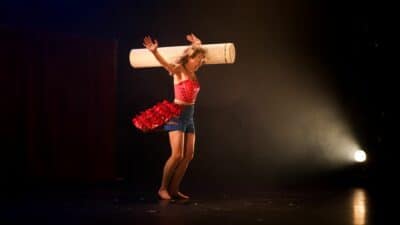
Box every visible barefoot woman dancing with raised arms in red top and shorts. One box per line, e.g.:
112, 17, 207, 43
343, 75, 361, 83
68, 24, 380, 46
133, 34, 206, 200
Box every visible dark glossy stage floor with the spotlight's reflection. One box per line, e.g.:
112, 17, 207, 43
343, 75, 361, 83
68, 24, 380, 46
1, 184, 389, 225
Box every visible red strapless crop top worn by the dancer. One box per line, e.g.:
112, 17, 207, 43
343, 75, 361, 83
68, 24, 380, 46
174, 79, 200, 103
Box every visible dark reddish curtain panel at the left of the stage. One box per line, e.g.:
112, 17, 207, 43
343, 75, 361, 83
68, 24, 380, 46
0, 28, 117, 184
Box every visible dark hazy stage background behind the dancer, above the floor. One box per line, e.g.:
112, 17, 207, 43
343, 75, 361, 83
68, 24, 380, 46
0, 0, 396, 190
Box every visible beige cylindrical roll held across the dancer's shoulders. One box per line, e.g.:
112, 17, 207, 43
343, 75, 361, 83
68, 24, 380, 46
129, 43, 236, 68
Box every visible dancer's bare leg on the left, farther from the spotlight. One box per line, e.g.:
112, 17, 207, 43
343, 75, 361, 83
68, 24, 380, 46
158, 131, 184, 200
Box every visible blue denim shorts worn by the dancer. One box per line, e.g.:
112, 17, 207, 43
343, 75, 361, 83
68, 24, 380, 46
163, 105, 195, 133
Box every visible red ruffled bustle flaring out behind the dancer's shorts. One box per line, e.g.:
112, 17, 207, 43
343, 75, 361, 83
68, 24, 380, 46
132, 100, 182, 132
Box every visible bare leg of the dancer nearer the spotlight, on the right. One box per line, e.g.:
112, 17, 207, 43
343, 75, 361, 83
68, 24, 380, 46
169, 133, 196, 199
